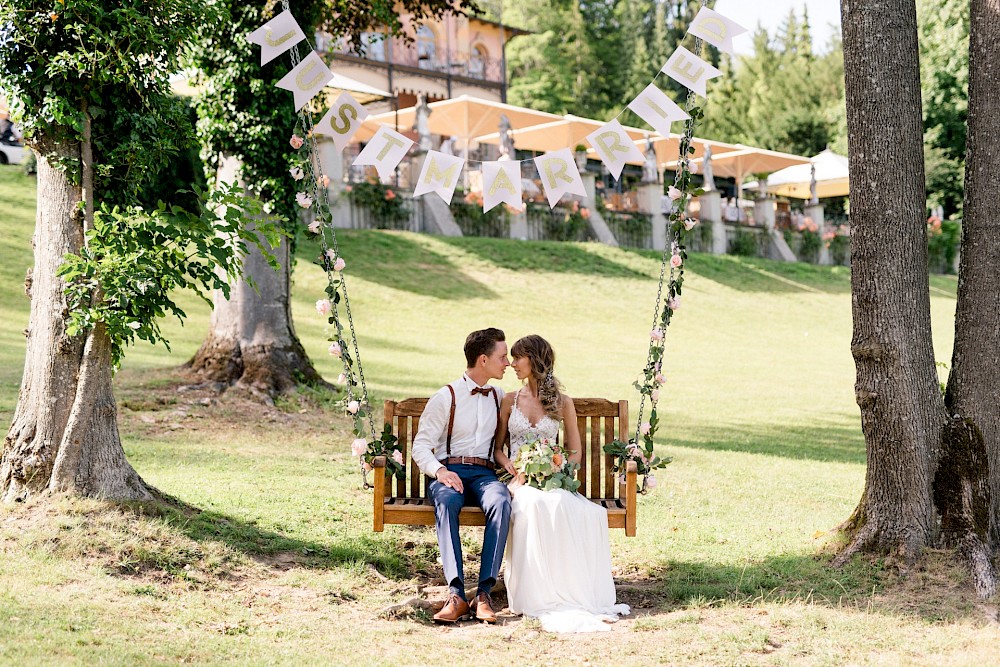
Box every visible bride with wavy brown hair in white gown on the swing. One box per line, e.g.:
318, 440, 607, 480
494, 336, 629, 632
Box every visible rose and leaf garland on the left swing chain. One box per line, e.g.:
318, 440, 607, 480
286, 36, 406, 489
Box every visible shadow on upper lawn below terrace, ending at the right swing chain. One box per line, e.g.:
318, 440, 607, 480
440, 237, 650, 280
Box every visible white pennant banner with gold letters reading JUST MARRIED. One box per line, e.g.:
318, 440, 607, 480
248, 7, 746, 211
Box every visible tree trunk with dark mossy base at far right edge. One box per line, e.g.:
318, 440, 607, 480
942, 0, 1000, 597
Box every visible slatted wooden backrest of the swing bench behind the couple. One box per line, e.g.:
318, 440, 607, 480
385, 398, 628, 500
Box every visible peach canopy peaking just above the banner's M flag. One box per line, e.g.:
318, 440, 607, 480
355, 95, 561, 146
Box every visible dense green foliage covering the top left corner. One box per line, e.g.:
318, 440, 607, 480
0, 0, 224, 205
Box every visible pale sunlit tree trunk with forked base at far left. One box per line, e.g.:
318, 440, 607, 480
0, 145, 149, 502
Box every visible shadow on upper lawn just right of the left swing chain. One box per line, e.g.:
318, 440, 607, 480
296, 230, 497, 299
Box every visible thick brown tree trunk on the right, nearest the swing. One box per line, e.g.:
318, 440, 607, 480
836, 0, 945, 563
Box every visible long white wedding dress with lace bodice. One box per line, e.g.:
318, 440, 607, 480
504, 396, 630, 632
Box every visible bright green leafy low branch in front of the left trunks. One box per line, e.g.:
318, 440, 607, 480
59, 185, 279, 369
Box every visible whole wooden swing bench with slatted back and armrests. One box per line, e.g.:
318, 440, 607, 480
372, 398, 637, 537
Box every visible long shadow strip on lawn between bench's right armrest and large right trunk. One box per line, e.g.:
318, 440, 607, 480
667, 420, 866, 464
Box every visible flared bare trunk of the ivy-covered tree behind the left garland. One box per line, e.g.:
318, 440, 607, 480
190, 157, 326, 396
